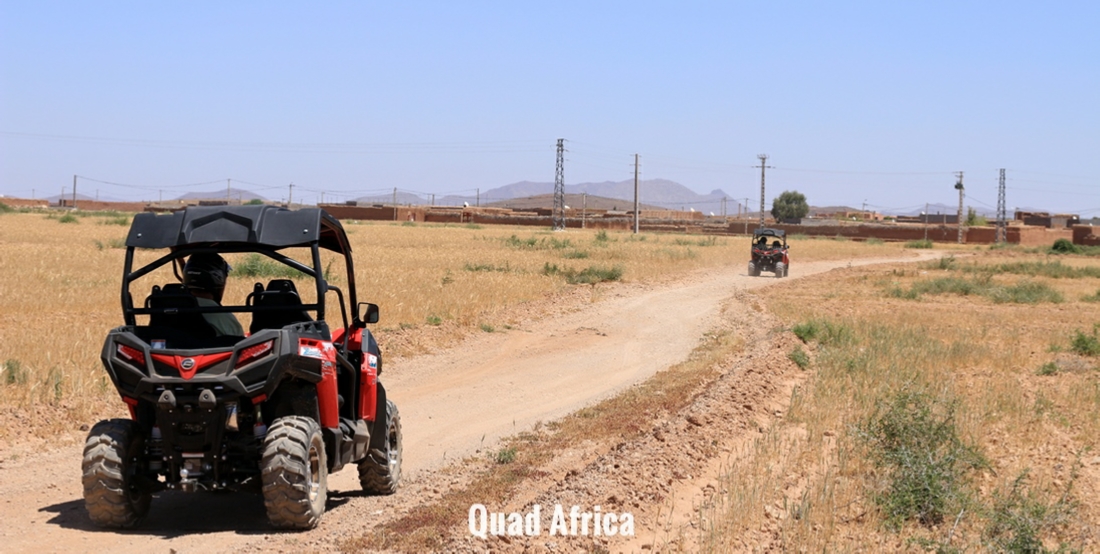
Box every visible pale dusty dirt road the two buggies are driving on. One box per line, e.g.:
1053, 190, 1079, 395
0, 252, 931, 552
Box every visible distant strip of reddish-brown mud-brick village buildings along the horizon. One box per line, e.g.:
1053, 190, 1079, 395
0, 195, 1100, 246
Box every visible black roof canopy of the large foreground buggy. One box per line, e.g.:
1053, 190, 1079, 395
127, 206, 351, 254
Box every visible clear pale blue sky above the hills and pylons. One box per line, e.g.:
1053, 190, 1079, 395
0, 0, 1100, 217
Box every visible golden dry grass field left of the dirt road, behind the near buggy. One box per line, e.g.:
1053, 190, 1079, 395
0, 212, 901, 441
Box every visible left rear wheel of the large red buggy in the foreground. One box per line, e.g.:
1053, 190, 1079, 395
81, 419, 153, 528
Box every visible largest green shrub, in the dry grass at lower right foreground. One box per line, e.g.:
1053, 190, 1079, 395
857, 389, 988, 529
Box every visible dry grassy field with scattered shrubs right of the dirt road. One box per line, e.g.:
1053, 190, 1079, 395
700, 248, 1100, 552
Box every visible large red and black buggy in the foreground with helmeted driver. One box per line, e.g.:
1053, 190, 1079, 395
83, 206, 402, 529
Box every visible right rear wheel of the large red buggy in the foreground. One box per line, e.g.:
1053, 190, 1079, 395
260, 416, 329, 529
